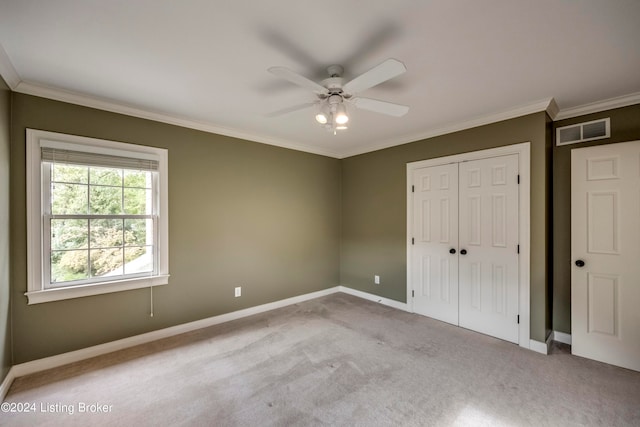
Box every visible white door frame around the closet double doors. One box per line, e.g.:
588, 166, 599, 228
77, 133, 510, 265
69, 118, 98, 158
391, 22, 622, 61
406, 142, 531, 348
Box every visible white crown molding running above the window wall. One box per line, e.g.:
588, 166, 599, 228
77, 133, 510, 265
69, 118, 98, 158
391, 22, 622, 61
13, 81, 339, 158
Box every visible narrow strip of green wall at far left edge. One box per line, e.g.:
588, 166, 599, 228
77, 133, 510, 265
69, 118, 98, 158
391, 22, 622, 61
0, 77, 11, 382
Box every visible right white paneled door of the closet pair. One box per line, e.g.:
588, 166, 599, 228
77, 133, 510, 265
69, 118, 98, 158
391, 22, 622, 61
459, 155, 519, 343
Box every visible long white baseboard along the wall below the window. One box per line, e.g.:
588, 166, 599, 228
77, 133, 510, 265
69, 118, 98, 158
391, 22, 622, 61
3, 286, 340, 385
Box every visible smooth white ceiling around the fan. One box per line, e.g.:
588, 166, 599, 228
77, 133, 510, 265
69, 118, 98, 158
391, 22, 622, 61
0, 0, 640, 157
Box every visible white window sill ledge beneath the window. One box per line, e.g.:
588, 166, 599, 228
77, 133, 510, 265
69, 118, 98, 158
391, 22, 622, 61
25, 274, 169, 305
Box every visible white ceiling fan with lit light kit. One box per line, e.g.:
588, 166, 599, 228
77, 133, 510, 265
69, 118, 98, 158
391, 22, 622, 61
268, 59, 409, 135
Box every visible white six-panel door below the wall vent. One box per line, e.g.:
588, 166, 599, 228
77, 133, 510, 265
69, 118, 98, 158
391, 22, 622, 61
571, 141, 640, 371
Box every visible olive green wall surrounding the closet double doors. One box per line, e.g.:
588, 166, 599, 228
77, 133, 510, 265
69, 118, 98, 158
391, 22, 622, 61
340, 112, 551, 341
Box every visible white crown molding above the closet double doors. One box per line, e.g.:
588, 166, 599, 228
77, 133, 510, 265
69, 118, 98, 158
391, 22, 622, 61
340, 98, 555, 159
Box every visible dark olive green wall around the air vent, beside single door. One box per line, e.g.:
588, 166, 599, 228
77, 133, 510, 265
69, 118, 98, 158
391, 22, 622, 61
553, 104, 640, 334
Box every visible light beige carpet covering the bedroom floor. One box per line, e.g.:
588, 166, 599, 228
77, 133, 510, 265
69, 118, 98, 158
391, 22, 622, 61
0, 294, 640, 426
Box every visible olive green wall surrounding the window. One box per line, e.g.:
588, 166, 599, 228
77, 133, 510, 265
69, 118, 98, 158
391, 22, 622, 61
11, 93, 341, 363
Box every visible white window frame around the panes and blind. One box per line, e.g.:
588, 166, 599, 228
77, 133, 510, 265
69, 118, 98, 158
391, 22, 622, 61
25, 129, 169, 304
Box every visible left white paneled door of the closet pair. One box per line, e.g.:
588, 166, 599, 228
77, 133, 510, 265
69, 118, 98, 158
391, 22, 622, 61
411, 163, 458, 325
